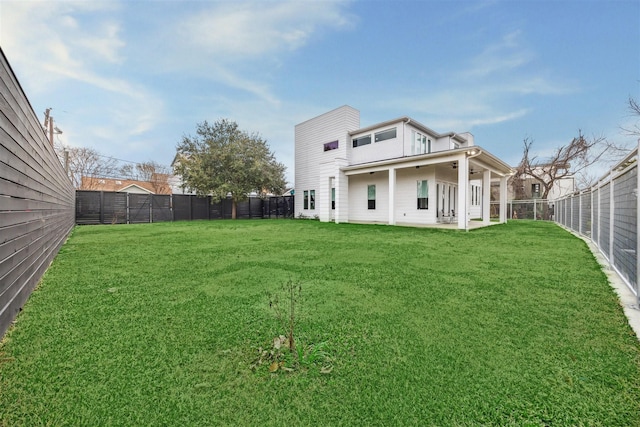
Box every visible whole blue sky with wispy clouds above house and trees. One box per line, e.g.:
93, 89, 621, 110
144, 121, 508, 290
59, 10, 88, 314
0, 0, 640, 182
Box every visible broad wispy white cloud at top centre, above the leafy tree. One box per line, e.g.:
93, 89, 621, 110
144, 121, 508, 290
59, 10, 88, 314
156, 0, 354, 106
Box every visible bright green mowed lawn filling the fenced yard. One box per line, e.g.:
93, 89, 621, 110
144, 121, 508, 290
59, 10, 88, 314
0, 220, 640, 426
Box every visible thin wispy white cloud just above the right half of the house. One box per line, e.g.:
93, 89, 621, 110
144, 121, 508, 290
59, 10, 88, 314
385, 31, 578, 131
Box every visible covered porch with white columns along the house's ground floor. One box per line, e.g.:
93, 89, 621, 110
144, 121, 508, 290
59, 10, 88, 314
336, 146, 513, 230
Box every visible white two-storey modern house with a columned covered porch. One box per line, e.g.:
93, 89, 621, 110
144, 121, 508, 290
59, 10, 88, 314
295, 105, 513, 229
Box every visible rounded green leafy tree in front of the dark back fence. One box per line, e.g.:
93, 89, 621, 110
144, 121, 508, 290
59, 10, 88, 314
174, 119, 286, 219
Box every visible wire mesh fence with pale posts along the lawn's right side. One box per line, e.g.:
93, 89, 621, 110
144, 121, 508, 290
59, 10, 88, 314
555, 149, 640, 304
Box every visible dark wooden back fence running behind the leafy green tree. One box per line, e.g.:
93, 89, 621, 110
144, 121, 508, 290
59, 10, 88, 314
76, 190, 294, 225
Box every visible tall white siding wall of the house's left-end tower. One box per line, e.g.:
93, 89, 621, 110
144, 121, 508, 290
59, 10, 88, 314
295, 105, 360, 217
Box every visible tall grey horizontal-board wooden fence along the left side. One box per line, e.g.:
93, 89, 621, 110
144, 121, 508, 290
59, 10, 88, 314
0, 49, 75, 336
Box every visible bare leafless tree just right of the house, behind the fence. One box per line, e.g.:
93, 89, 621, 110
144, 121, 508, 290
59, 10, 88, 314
511, 131, 628, 199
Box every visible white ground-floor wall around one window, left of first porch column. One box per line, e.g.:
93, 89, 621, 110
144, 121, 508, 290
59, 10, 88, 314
349, 171, 388, 224
